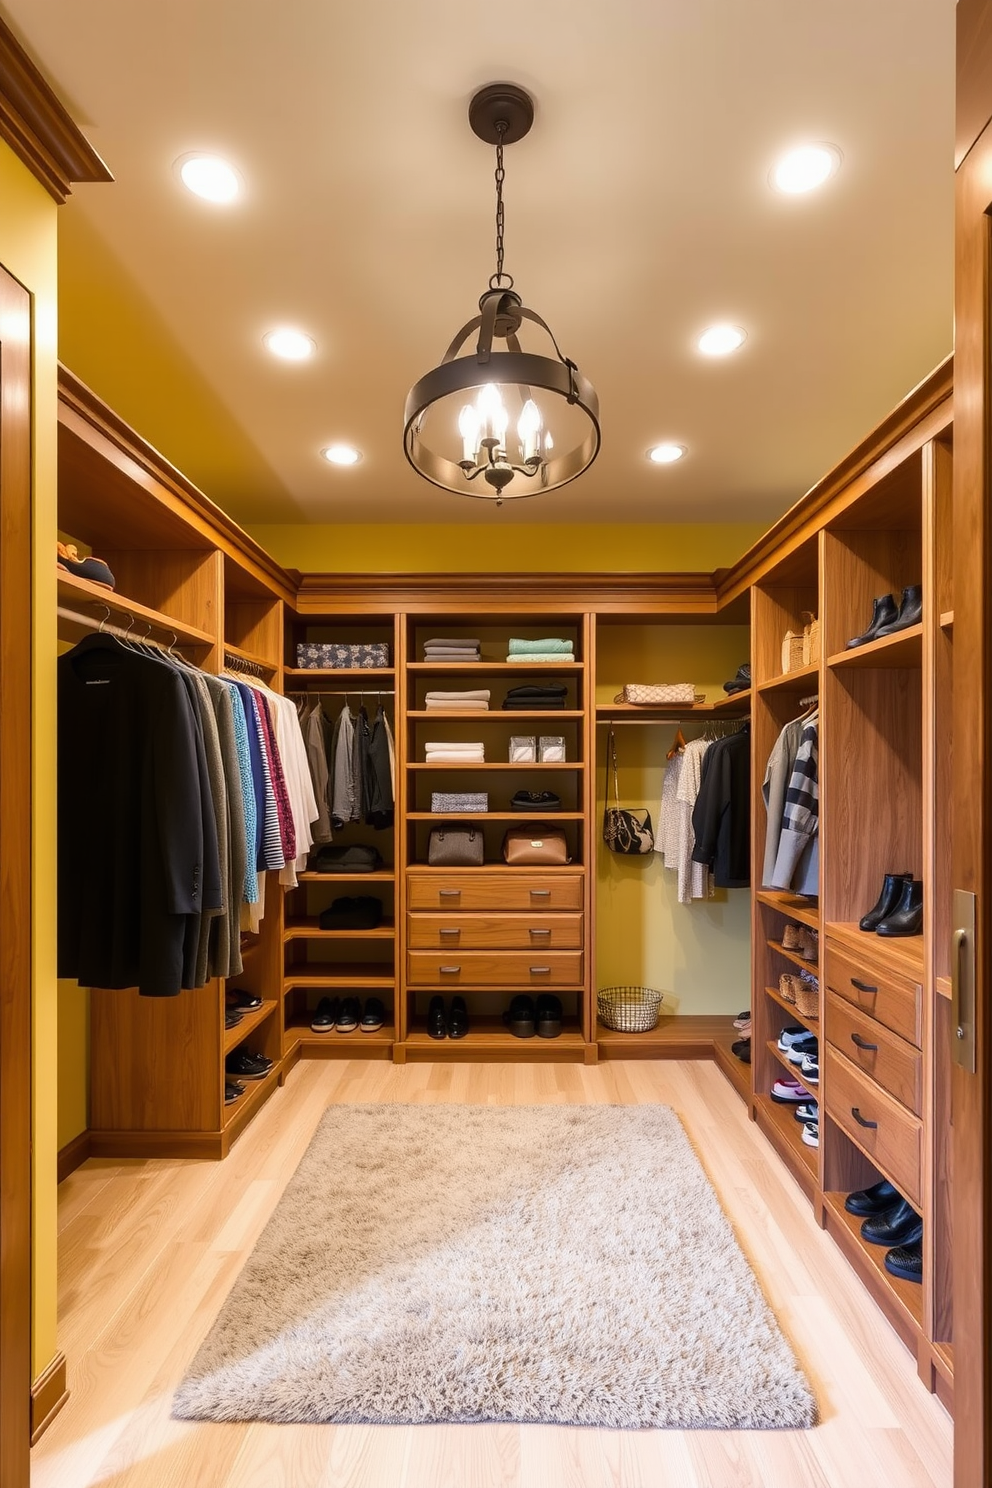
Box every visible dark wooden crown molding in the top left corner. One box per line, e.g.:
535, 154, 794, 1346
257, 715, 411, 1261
0, 21, 113, 205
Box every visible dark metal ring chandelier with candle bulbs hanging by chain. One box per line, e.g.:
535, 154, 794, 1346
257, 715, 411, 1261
403, 83, 599, 506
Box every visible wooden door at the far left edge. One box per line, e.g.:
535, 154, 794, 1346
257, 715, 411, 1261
0, 258, 31, 1484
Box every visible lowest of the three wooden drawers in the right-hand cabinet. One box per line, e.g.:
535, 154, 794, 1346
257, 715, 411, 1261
824, 1046, 924, 1210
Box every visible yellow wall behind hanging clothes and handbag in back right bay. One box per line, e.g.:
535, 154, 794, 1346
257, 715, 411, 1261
595, 622, 751, 1015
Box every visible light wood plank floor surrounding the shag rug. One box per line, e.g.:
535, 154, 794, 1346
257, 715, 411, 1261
31, 1061, 952, 1488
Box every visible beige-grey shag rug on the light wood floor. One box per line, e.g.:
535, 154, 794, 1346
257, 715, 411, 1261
173, 1104, 817, 1428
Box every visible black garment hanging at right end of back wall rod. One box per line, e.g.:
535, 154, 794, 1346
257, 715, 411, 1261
693, 726, 751, 888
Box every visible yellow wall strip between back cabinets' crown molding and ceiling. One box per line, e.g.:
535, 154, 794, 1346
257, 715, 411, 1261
250, 522, 764, 573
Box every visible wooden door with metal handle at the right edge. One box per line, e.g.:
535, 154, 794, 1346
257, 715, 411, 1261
950, 0, 992, 1488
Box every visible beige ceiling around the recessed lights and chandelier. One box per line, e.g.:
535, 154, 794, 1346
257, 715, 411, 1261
0, 0, 955, 524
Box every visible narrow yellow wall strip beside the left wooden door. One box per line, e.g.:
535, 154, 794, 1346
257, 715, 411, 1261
0, 143, 58, 1376
